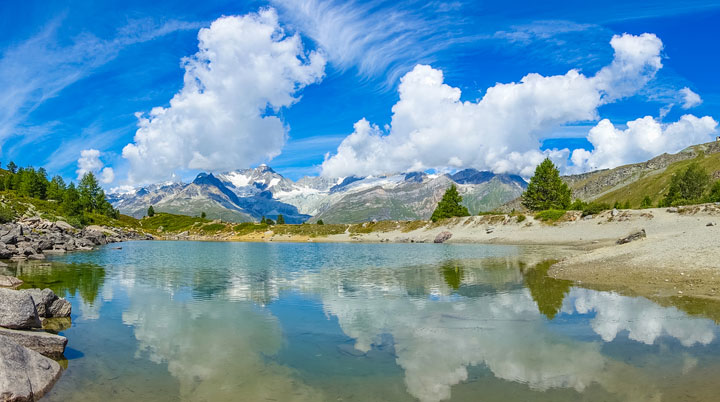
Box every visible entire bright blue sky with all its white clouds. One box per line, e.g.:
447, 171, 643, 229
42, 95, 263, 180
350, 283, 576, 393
0, 0, 720, 189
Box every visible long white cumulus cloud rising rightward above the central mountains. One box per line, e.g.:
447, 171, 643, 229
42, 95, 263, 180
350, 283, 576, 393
322, 34, 663, 176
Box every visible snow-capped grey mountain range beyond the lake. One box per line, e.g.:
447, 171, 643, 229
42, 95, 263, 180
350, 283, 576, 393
109, 165, 527, 223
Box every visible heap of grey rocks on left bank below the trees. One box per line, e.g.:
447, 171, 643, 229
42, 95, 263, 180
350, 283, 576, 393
0, 217, 152, 261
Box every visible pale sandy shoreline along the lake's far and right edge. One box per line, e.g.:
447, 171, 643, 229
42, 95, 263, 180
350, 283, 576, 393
156, 204, 720, 301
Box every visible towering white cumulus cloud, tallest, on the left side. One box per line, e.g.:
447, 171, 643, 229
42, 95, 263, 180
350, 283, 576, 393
123, 9, 325, 183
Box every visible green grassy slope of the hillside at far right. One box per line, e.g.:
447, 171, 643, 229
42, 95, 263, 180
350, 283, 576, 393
597, 153, 720, 208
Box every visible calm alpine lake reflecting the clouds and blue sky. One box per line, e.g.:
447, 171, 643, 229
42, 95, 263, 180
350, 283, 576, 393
5, 241, 720, 402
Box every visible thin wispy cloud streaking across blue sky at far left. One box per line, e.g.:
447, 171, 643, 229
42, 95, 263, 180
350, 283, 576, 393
0, 18, 200, 153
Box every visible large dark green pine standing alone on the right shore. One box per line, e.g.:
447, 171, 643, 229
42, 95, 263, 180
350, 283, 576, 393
522, 158, 571, 211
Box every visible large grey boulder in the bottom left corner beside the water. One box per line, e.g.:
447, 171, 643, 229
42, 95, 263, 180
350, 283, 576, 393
0, 337, 62, 402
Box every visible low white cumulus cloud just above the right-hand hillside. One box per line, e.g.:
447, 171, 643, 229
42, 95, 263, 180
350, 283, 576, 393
571, 114, 718, 171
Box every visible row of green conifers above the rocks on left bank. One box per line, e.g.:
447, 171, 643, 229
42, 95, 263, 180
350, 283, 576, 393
0, 162, 120, 223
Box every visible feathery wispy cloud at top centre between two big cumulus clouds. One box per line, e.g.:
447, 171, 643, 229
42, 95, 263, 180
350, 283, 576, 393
272, 0, 461, 84
